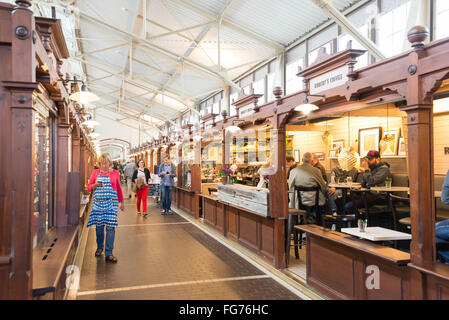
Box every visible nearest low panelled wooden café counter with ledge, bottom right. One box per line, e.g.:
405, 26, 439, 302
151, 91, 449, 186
295, 225, 410, 300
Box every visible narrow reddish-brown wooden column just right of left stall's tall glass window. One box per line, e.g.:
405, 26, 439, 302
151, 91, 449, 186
55, 117, 70, 227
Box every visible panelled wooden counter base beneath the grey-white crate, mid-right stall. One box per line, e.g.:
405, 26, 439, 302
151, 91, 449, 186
200, 184, 276, 264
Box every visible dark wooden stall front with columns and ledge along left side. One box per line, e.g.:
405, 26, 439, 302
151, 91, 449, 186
0, 1, 96, 299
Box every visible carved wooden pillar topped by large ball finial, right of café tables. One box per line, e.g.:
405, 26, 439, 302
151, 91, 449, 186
401, 27, 436, 299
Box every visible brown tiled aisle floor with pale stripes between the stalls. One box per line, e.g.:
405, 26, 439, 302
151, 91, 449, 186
78, 198, 300, 300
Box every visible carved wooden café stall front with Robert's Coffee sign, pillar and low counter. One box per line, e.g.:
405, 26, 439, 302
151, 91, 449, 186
274, 27, 449, 299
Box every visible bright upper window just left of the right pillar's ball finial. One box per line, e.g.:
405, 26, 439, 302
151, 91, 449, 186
378, 2, 410, 57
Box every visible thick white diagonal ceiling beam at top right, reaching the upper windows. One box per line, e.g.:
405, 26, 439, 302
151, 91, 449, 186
313, 0, 385, 60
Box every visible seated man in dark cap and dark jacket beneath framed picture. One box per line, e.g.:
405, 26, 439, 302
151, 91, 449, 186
345, 150, 392, 214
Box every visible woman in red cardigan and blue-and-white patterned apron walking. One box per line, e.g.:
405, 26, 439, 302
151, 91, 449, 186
87, 153, 125, 263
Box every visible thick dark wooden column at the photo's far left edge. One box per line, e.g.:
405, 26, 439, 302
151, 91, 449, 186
0, 1, 37, 299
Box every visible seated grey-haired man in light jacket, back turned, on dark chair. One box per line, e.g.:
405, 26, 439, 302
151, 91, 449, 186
288, 152, 335, 223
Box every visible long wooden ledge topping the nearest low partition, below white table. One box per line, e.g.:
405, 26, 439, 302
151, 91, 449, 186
295, 224, 410, 265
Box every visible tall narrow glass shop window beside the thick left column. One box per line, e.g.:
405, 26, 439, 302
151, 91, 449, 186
33, 113, 51, 248
